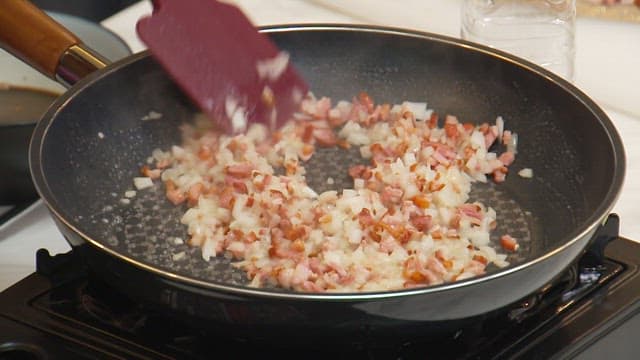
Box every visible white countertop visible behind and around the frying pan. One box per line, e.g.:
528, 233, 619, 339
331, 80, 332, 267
0, 0, 640, 291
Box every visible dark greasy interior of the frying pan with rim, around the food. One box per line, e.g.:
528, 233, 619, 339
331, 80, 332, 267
30, 27, 624, 301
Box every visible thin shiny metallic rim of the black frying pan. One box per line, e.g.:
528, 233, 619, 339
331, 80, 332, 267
29, 24, 626, 302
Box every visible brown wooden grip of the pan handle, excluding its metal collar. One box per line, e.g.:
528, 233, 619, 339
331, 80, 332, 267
0, 0, 80, 78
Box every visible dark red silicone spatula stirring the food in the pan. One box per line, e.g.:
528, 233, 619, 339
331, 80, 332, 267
137, 0, 308, 134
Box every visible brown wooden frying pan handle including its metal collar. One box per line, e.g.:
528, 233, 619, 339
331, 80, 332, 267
0, 0, 108, 87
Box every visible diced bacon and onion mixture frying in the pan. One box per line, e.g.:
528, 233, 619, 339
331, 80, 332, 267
142, 93, 518, 292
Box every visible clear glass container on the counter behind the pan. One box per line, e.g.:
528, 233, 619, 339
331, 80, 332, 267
461, 0, 576, 81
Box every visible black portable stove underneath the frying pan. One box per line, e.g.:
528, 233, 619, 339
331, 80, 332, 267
0, 218, 640, 359
